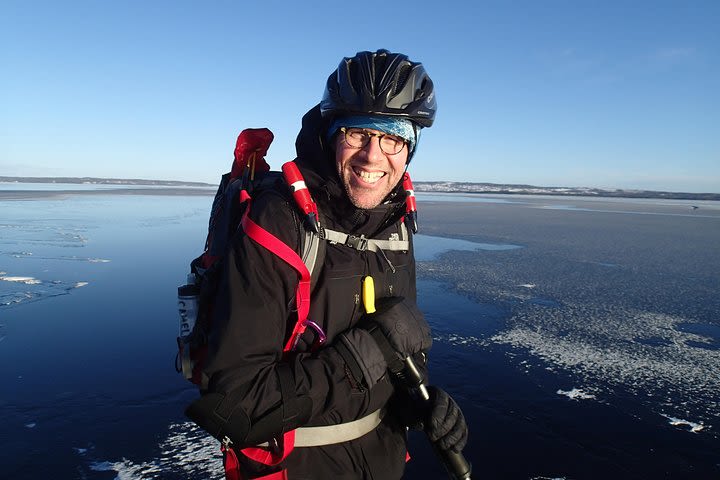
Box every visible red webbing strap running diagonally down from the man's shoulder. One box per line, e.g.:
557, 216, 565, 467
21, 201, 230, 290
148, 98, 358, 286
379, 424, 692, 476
242, 199, 310, 352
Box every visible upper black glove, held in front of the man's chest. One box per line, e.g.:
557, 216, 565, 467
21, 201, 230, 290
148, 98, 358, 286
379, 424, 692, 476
364, 297, 432, 373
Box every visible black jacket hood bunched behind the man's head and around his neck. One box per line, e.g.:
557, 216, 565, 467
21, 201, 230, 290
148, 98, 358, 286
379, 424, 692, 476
295, 104, 405, 234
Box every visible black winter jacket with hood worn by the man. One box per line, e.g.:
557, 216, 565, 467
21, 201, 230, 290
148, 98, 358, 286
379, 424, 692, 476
205, 107, 416, 480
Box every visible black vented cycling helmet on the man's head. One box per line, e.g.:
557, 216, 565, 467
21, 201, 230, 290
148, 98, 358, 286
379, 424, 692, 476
320, 50, 437, 127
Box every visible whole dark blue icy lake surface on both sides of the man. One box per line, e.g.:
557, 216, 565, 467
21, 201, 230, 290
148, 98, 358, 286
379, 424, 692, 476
0, 184, 720, 480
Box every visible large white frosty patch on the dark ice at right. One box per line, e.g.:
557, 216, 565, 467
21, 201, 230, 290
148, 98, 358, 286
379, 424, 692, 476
490, 310, 720, 431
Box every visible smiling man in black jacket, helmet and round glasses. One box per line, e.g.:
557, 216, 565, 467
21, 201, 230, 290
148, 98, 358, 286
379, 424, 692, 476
187, 50, 467, 480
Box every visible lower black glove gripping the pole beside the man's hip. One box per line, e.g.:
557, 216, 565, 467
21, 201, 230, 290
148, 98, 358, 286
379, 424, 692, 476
425, 386, 468, 452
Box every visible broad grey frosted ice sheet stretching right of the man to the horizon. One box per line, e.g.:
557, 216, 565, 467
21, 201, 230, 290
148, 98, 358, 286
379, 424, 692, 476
418, 194, 720, 450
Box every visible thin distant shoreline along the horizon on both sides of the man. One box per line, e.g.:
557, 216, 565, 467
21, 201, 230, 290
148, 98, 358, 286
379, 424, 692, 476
0, 176, 720, 201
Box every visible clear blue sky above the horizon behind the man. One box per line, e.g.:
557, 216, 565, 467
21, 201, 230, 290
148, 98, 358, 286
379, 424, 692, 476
0, 0, 720, 193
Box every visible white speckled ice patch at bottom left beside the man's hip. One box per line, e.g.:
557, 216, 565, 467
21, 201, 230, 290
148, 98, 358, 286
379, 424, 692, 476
82, 422, 225, 480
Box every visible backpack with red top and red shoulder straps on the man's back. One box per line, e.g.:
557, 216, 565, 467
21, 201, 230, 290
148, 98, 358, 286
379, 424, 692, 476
175, 128, 324, 390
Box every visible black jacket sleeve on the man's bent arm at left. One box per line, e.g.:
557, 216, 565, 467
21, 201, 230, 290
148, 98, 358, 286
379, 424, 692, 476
194, 189, 392, 443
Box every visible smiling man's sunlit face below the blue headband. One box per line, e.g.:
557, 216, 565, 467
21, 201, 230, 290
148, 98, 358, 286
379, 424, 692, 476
335, 129, 408, 209
